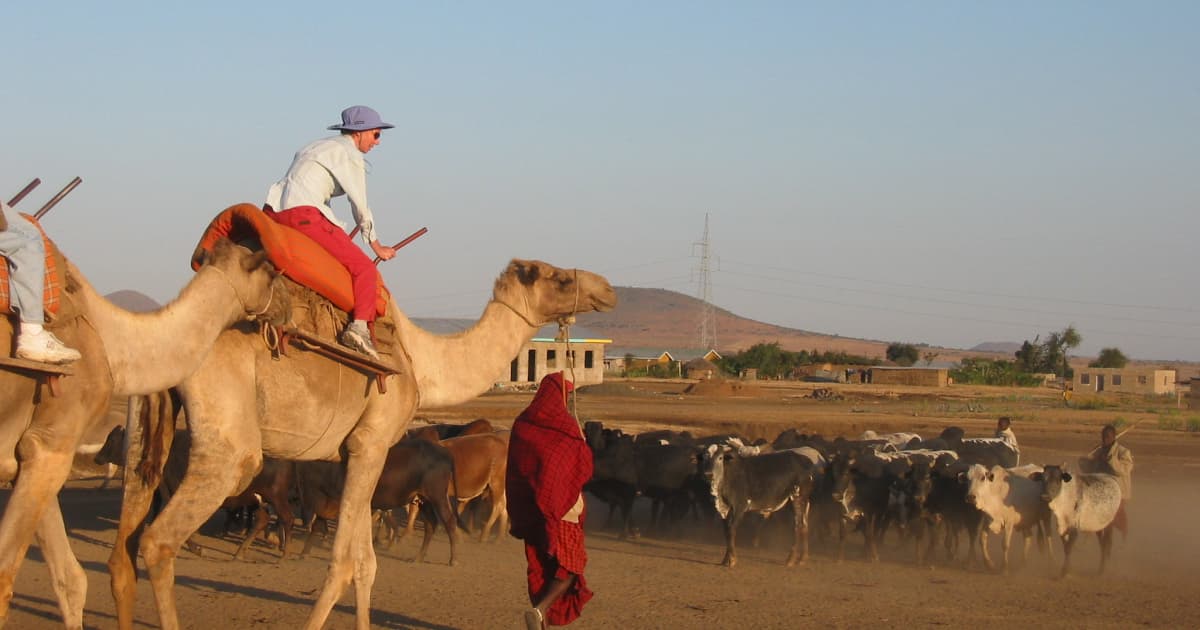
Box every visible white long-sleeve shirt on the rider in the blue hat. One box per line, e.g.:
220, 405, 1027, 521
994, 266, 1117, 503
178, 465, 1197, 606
266, 134, 378, 246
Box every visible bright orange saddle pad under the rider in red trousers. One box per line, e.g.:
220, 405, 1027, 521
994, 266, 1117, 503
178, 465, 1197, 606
192, 204, 390, 316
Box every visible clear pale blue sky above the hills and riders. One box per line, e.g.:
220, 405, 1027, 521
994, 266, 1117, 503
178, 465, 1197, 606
0, 0, 1200, 361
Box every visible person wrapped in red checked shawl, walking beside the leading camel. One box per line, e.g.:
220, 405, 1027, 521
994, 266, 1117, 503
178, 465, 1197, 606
505, 372, 593, 630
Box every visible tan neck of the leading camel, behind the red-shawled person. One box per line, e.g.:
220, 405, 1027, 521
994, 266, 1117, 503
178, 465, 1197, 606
396, 301, 538, 408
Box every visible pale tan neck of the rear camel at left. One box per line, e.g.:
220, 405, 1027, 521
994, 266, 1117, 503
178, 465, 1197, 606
79, 269, 242, 396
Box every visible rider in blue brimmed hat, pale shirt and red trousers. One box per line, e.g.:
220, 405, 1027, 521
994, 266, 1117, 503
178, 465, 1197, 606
265, 106, 396, 359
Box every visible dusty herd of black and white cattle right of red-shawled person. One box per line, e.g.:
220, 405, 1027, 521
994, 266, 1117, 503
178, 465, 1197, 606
584, 422, 1123, 574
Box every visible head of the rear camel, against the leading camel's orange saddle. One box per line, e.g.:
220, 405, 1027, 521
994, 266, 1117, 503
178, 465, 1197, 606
200, 239, 292, 325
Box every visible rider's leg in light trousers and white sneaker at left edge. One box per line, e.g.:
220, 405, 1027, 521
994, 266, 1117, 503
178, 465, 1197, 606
0, 196, 79, 364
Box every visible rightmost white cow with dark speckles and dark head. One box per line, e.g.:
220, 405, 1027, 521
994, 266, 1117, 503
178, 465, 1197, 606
1032, 466, 1121, 576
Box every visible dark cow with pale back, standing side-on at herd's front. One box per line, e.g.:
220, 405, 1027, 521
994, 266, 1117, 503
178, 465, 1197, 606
701, 444, 816, 566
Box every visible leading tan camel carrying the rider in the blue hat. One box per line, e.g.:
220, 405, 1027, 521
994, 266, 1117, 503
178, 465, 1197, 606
108, 260, 617, 630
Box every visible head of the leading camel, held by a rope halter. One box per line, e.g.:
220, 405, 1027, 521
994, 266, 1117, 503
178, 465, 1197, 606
492, 259, 617, 325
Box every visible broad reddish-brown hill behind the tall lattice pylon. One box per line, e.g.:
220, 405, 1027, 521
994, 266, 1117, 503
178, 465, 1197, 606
578, 287, 991, 361
